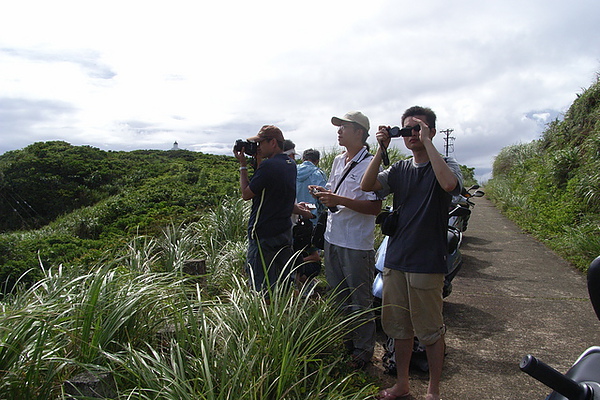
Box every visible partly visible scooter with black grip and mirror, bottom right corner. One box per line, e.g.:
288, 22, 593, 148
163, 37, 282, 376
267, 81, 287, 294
520, 257, 600, 400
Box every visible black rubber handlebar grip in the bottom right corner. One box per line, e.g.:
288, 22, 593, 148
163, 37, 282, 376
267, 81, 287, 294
520, 354, 593, 400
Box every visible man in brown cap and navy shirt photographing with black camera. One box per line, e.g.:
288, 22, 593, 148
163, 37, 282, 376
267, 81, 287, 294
234, 125, 296, 291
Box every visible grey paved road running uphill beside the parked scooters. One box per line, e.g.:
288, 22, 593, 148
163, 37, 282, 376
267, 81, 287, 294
375, 198, 600, 400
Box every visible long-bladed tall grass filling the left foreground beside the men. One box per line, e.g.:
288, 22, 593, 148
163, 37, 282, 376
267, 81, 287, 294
0, 193, 373, 399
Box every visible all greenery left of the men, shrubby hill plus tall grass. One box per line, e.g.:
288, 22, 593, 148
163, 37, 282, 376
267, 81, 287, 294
0, 138, 473, 399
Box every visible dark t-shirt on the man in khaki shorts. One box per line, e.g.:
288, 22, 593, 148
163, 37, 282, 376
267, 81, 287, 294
378, 158, 462, 274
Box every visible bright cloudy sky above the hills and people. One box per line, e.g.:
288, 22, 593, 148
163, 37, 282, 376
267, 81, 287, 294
0, 0, 600, 180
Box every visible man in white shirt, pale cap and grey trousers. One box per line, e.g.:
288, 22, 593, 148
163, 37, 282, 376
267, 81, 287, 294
309, 111, 381, 369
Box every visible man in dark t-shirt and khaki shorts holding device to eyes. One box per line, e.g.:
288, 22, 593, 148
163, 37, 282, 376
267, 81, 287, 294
361, 106, 462, 400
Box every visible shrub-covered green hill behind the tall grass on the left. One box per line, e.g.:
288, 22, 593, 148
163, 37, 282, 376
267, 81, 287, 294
0, 141, 238, 289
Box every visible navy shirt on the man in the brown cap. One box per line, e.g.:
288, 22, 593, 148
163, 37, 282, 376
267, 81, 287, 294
248, 153, 296, 239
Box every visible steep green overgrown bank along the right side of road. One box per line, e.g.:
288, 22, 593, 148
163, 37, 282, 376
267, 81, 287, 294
486, 74, 600, 269
